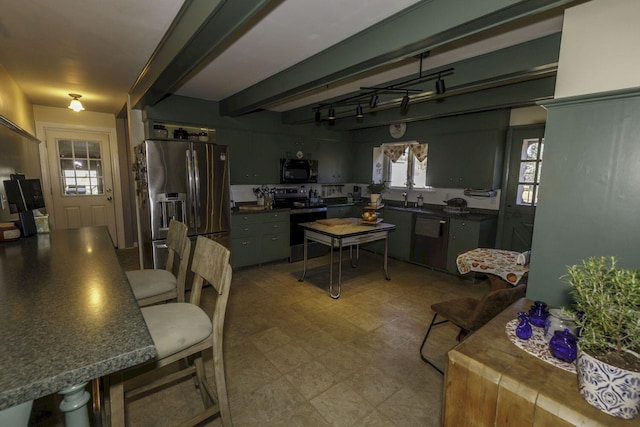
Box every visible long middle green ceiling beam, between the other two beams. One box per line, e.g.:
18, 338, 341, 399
220, 0, 575, 116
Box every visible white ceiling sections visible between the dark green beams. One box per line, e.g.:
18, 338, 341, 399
0, 0, 562, 117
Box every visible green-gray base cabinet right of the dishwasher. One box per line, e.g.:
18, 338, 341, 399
447, 217, 498, 274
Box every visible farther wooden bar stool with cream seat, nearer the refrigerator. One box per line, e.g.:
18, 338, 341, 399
126, 219, 191, 307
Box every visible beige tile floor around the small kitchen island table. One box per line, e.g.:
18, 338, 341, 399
31, 251, 489, 427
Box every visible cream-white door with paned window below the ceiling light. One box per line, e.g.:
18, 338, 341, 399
45, 128, 117, 246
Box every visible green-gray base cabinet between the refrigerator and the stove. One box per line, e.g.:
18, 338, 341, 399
231, 211, 289, 268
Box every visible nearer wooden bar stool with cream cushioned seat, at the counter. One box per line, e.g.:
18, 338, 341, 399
109, 236, 232, 426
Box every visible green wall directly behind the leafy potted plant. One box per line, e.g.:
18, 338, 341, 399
527, 88, 640, 305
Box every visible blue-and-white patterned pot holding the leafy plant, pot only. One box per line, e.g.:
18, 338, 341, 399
576, 351, 640, 420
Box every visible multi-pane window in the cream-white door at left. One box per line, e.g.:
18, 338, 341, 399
58, 139, 104, 196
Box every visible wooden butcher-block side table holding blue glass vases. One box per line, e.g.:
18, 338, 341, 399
442, 298, 639, 427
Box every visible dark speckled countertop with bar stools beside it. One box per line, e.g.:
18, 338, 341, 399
0, 227, 155, 410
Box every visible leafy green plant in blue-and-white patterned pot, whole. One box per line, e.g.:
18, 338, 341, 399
564, 256, 640, 419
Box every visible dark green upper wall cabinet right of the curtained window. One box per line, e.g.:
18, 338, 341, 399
427, 130, 504, 189
